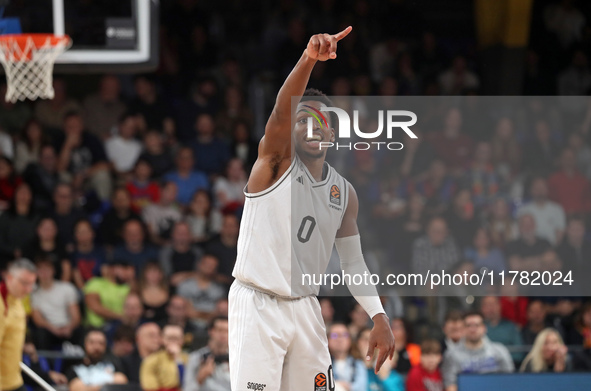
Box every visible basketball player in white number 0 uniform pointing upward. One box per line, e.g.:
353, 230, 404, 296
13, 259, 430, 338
229, 27, 394, 391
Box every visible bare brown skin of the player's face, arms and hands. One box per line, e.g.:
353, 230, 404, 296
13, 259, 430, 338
248, 27, 395, 374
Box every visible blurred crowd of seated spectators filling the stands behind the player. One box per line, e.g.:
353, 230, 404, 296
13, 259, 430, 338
0, 0, 591, 391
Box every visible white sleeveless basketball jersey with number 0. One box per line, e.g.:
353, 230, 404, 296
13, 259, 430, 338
232, 156, 349, 297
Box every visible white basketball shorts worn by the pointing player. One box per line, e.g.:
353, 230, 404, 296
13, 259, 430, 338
228, 280, 334, 391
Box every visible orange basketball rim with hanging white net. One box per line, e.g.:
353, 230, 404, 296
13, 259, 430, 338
0, 34, 72, 103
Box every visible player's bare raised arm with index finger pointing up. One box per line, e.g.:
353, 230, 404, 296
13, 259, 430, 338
248, 26, 353, 193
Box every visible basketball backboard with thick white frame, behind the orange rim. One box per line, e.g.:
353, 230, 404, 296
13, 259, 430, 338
4, 0, 159, 73
